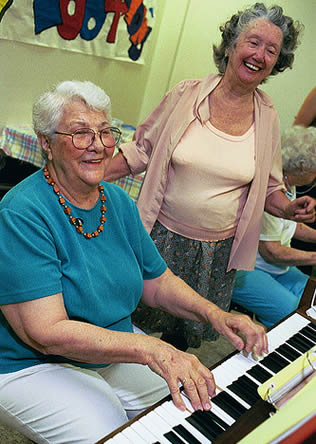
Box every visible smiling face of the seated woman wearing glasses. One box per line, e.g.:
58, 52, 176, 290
43, 101, 114, 199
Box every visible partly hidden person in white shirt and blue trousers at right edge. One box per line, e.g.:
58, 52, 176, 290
232, 126, 316, 327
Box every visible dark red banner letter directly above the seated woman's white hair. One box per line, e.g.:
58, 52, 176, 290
57, 0, 86, 40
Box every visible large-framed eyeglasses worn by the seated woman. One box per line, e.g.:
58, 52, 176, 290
55, 126, 122, 150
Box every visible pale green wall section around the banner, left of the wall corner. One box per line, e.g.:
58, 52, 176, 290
0, 0, 165, 126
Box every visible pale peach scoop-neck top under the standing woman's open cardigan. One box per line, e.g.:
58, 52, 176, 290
158, 119, 255, 240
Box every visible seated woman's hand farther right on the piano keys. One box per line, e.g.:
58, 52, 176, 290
210, 309, 268, 356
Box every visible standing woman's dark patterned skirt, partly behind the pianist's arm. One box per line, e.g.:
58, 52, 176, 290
132, 221, 236, 348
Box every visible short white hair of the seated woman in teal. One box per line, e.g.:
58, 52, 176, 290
33, 80, 111, 138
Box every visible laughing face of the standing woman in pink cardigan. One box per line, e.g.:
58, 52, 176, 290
225, 19, 282, 90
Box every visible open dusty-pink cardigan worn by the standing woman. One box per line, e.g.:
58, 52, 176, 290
120, 75, 284, 271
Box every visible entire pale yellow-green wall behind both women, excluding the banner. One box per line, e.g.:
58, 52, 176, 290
0, 0, 316, 132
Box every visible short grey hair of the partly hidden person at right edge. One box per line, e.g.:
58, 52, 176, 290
281, 125, 316, 172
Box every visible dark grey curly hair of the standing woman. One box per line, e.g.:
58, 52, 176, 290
213, 3, 304, 83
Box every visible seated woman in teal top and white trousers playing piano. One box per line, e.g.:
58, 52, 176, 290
0, 81, 267, 444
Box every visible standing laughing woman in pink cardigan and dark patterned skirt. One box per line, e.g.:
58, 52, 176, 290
106, 3, 315, 350
